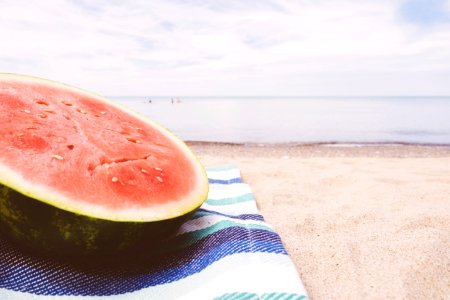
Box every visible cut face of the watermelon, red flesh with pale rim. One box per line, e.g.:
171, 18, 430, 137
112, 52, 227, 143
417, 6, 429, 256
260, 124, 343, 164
0, 75, 208, 221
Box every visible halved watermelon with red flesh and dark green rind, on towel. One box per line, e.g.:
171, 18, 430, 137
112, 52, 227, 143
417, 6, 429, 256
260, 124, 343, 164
0, 74, 208, 255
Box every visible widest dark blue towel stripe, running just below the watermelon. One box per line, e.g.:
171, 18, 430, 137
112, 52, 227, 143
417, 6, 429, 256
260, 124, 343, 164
0, 227, 286, 296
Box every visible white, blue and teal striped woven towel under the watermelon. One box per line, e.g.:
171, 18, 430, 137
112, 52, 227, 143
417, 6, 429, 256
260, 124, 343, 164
0, 165, 307, 300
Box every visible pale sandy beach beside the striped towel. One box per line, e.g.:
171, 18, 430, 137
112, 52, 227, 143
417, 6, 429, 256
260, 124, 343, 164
189, 143, 450, 299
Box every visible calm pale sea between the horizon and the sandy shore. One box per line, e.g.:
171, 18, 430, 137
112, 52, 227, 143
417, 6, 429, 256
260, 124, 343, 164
112, 97, 450, 145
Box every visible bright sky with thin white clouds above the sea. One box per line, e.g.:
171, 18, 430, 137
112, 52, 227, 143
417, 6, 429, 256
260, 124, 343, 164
0, 0, 450, 96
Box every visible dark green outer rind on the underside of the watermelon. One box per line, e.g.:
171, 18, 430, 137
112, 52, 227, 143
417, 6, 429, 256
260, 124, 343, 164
0, 185, 193, 262
